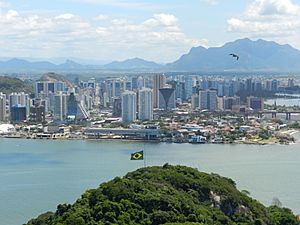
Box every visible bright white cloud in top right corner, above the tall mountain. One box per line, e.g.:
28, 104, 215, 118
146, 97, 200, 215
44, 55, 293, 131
227, 0, 300, 38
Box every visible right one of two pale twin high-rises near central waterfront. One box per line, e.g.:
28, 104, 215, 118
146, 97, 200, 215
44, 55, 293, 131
138, 88, 153, 120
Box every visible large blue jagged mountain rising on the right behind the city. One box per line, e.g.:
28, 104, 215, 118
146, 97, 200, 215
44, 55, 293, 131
168, 38, 300, 72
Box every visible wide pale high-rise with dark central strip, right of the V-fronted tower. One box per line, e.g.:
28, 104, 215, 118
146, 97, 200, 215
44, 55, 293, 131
199, 90, 217, 111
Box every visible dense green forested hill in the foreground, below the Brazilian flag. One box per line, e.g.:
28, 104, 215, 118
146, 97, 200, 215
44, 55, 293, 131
24, 164, 299, 225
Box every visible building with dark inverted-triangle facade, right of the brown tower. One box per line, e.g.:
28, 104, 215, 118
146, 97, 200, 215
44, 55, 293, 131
159, 88, 176, 110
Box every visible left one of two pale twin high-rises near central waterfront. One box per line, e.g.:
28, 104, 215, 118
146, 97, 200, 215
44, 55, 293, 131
122, 91, 137, 123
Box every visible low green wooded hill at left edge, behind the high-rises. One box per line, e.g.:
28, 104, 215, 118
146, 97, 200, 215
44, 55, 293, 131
0, 76, 33, 94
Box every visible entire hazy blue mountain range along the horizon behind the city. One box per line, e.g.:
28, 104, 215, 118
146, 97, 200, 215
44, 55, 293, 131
0, 38, 300, 73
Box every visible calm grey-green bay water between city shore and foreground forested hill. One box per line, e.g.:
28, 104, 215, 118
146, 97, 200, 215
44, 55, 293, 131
0, 139, 300, 225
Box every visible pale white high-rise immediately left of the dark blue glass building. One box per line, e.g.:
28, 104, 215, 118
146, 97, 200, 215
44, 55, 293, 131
53, 92, 67, 121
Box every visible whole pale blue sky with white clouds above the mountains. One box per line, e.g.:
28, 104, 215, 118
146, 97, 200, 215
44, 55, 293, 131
0, 0, 300, 63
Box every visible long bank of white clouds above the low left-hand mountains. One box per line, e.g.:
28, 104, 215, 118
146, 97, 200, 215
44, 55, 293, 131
0, 6, 207, 62
